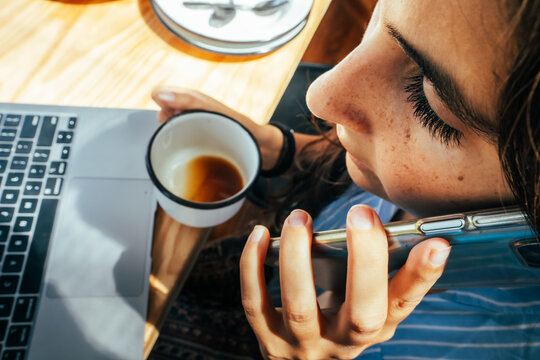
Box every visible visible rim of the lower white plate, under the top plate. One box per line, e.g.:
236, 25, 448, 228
154, 0, 307, 55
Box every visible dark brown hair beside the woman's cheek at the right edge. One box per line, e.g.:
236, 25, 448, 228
498, 0, 540, 234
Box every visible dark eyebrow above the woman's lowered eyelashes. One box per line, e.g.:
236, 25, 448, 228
386, 24, 497, 137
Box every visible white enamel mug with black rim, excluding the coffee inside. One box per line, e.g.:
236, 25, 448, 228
146, 111, 261, 227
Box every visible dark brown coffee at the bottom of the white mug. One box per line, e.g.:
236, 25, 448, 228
177, 155, 244, 202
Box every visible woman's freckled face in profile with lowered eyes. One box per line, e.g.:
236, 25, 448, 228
307, 0, 512, 216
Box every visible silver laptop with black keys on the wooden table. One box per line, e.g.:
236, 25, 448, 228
0, 103, 158, 360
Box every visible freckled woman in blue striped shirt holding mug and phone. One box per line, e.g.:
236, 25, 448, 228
154, 0, 540, 359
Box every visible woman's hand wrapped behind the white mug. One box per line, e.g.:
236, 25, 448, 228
152, 87, 283, 169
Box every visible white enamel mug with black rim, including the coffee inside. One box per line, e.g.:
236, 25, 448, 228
146, 111, 261, 227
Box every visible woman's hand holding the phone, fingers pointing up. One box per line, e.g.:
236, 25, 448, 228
240, 205, 450, 359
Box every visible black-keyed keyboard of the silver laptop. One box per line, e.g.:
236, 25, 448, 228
0, 109, 77, 360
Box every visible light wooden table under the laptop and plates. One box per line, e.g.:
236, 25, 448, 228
0, 0, 330, 358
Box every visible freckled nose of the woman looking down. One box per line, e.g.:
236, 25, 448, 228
306, 22, 400, 133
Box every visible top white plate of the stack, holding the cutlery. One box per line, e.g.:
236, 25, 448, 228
153, 0, 313, 43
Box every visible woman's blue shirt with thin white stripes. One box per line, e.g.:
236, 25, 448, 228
314, 185, 540, 360
